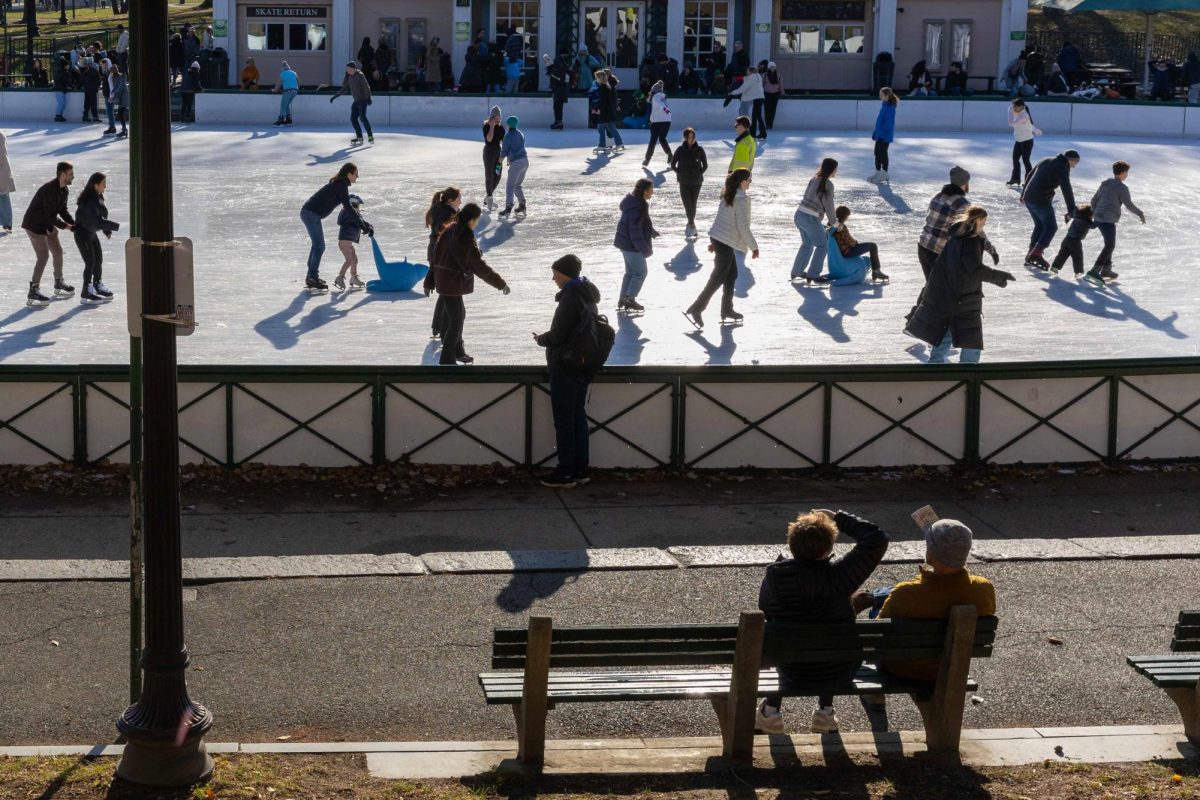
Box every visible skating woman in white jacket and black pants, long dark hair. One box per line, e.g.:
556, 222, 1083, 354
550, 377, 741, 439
683, 169, 758, 330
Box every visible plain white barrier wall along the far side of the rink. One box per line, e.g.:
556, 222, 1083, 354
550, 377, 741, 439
0, 90, 1200, 139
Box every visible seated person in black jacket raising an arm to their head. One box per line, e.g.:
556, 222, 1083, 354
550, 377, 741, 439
755, 509, 888, 733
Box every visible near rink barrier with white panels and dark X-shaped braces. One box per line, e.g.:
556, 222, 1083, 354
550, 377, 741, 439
0, 357, 1200, 469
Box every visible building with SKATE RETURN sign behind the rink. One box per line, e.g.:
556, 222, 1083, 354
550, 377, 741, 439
214, 0, 1026, 92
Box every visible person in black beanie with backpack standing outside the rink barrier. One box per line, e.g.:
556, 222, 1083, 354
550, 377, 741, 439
533, 253, 600, 489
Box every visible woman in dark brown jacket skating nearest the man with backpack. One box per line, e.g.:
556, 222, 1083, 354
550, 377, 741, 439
425, 203, 509, 366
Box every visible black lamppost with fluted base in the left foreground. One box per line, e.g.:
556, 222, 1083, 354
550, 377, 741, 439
113, 0, 212, 787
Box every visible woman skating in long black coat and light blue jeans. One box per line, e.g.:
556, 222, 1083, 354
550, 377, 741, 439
905, 205, 1016, 363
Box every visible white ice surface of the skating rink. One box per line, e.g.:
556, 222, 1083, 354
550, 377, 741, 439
0, 120, 1200, 366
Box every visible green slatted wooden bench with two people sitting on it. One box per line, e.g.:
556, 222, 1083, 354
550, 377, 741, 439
479, 606, 996, 768
